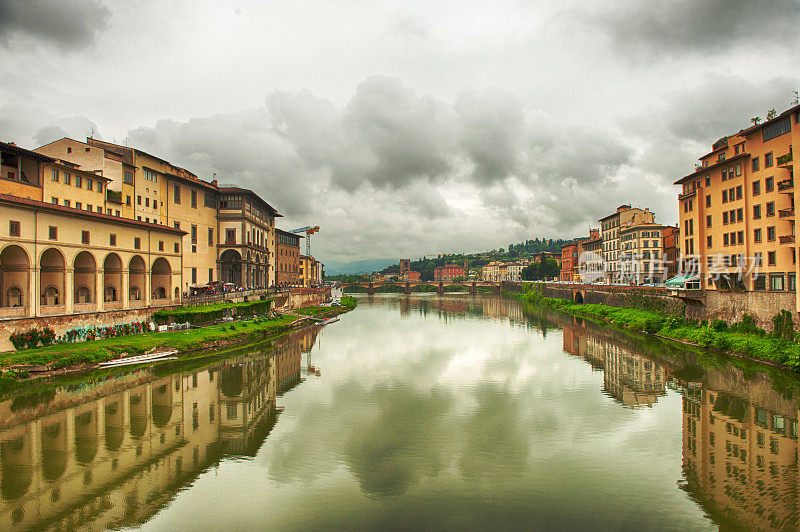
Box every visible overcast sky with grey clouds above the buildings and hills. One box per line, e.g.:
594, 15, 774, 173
0, 0, 800, 261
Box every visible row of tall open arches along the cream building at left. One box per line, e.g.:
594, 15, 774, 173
0, 245, 177, 309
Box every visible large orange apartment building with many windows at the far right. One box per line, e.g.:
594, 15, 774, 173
675, 106, 800, 308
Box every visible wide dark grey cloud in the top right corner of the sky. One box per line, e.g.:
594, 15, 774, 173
578, 0, 800, 55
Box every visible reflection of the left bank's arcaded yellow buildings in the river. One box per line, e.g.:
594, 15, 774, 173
0, 328, 318, 530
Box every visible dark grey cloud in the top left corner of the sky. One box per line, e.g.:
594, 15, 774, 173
0, 0, 111, 50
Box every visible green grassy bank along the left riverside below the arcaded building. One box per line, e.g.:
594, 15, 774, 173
0, 297, 356, 377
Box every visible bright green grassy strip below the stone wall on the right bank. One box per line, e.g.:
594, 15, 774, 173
509, 287, 800, 370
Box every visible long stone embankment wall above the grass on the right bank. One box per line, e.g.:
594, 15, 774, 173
510, 283, 800, 331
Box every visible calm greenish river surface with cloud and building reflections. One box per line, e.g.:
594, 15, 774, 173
0, 294, 800, 530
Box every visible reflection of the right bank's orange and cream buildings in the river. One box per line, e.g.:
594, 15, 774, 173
560, 317, 800, 530
